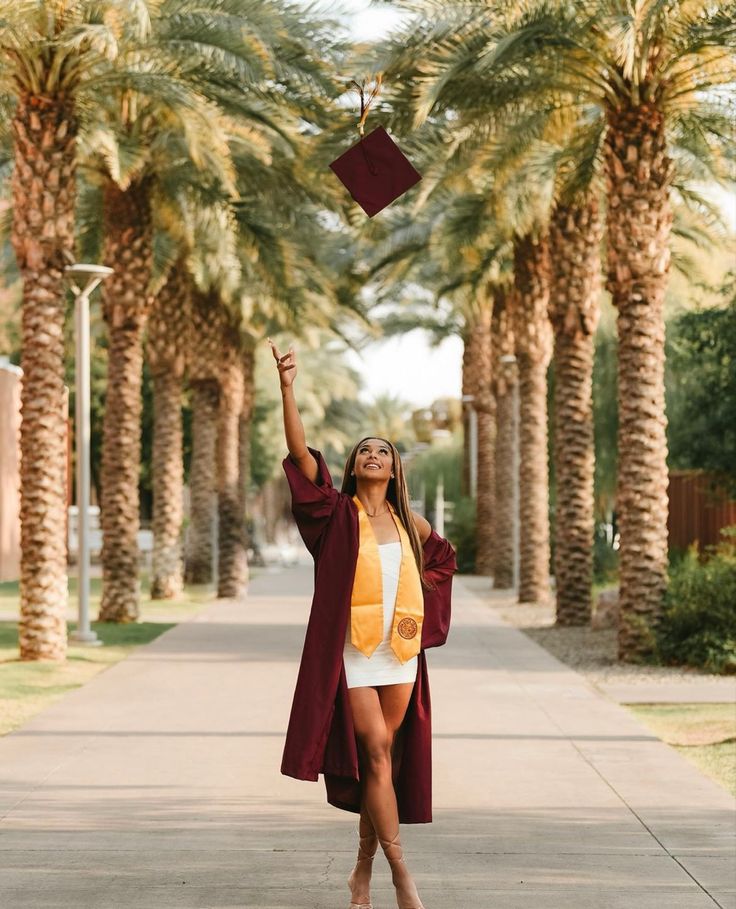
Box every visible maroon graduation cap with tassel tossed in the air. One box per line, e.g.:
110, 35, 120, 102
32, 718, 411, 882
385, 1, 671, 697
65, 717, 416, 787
330, 76, 422, 218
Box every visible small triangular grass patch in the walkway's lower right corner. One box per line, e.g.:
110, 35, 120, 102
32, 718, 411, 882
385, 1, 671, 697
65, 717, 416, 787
625, 704, 736, 796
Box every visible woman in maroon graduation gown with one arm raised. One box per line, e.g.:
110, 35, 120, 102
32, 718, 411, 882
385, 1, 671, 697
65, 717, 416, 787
269, 341, 456, 909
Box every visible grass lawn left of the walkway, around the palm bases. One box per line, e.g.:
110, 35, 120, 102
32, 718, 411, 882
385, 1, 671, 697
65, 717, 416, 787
0, 576, 212, 735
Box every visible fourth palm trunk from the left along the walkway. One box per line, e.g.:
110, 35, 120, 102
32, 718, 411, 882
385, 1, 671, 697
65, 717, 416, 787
185, 379, 220, 584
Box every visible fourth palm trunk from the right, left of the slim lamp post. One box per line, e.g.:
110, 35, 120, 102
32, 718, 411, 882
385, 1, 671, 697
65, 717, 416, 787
493, 289, 519, 590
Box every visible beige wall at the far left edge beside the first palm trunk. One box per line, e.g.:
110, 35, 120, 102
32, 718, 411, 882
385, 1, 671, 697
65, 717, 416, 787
0, 365, 21, 581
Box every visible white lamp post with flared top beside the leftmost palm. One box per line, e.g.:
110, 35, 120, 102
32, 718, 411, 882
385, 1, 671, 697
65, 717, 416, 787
64, 264, 113, 646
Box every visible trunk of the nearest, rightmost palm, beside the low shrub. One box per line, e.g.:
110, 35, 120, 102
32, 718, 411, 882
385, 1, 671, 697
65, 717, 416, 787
604, 104, 672, 661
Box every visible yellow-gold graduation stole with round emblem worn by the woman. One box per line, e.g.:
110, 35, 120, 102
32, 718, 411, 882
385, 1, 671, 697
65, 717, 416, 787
350, 495, 424, 663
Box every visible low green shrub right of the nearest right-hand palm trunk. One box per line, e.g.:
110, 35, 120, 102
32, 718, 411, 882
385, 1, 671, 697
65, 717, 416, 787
657, 528, 736, 673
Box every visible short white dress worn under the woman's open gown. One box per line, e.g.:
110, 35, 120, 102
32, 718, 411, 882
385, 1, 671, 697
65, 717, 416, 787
343, 540, 418, 688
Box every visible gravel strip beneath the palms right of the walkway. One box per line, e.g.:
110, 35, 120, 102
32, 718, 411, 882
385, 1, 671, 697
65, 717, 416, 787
493, 603, 733, 688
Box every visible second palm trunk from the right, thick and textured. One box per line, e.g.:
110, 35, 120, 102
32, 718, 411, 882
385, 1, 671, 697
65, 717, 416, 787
549, 197, 601, 625
